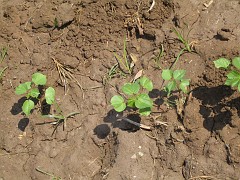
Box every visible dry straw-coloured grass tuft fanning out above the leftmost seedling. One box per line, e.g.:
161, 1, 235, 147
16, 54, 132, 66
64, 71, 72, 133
52, 57, 84, 98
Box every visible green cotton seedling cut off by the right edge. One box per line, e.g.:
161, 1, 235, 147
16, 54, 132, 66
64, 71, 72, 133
213, 57, 240, 91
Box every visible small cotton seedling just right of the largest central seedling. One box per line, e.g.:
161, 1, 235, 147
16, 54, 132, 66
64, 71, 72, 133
162, 69, 190, 96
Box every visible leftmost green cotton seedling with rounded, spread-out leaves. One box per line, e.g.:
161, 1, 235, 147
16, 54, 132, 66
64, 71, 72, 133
15, 72, 55, 116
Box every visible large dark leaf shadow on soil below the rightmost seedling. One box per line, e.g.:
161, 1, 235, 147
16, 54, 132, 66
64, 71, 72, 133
193, 86, 234, 132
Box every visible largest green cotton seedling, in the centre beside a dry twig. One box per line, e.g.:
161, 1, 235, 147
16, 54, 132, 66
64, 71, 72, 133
111, 77, 153, 116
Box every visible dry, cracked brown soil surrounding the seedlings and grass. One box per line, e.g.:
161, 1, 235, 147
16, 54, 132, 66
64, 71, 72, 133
0, 0, 240, 180
